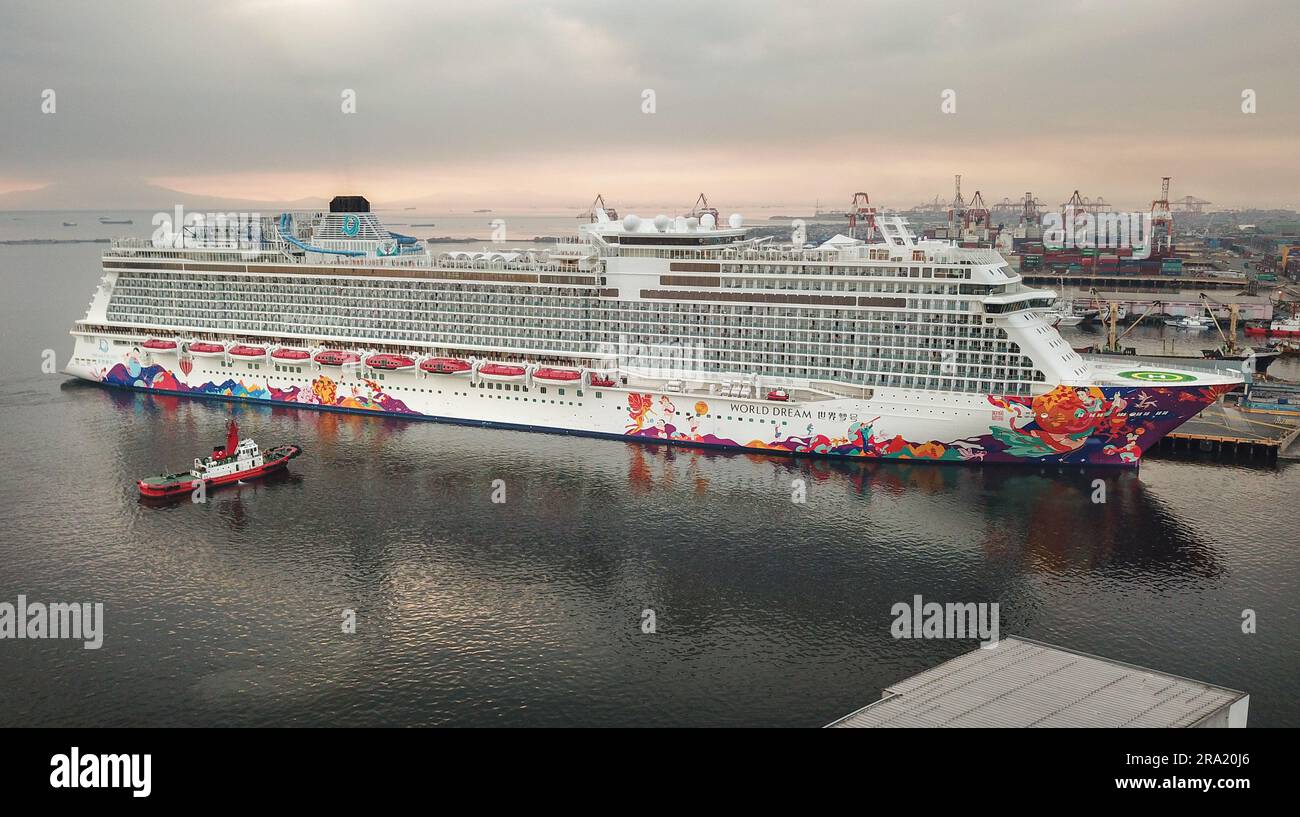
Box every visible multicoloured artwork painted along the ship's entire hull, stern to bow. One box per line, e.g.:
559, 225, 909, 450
88, 356, 1232, 466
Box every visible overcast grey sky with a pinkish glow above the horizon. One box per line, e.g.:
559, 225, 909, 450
0, 0, 1300, 209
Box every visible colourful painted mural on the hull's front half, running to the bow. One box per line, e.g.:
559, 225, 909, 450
627, 385, 1232, 464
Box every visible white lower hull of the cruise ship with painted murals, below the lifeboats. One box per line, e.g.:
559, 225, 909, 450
66, 337, 1226, 466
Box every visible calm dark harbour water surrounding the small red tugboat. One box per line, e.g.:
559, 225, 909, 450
0, 232, 1300, 726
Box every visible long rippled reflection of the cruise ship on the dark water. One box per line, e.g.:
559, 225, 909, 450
94, 381, 1221, 583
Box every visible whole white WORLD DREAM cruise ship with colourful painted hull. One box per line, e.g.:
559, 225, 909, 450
66, 196, 1242, 466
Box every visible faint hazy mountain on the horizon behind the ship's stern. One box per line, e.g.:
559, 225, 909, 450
0, 181, 329, 211
